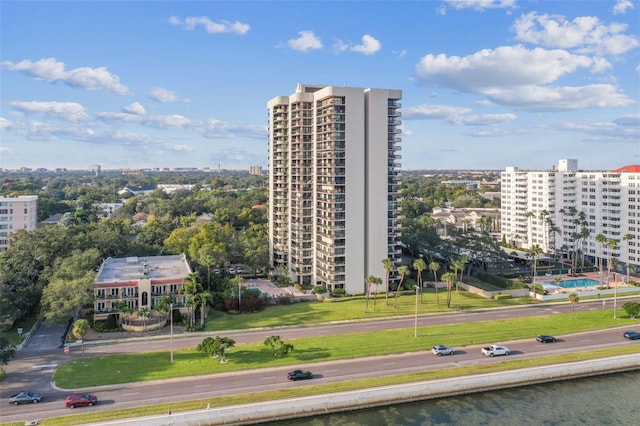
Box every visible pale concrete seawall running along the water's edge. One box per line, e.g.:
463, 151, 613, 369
86, 354, 640, 426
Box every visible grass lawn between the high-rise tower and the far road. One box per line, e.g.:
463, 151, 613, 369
205, 288, 541, 331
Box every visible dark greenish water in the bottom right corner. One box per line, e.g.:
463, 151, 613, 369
268, 371, 640, 426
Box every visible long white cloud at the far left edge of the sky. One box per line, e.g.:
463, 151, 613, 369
2, 58, 129, 95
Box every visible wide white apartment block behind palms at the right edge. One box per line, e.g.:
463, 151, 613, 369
500, 159, 640, 272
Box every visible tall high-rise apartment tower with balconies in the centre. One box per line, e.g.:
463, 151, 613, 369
267, 84, 402, 294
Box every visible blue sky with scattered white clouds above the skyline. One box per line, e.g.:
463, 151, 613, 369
0, 0, 640, 169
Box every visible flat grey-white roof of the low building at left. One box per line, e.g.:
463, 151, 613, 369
95, 253, 192, 283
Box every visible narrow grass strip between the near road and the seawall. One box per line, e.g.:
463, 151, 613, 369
38, 345, 640, 426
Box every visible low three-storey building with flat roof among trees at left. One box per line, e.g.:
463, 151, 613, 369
93, 254, 192, 320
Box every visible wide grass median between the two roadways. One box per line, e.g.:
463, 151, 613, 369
53, 310, 640, 389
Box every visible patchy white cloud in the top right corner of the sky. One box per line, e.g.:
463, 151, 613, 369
513, 12, 640, 55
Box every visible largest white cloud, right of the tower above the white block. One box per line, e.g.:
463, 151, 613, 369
416, 46, 633, 111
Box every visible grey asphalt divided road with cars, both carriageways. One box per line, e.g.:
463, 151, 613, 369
0, 302, 638, 422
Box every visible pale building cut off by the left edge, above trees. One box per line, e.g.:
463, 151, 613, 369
0, 195, 38, 253
